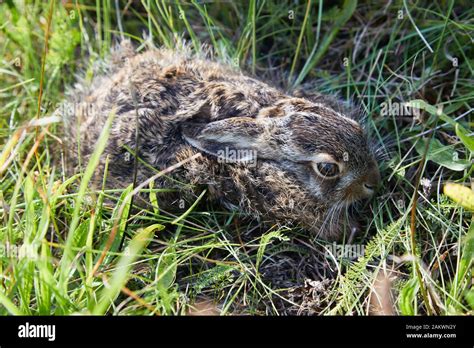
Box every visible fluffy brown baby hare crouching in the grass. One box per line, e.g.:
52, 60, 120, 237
62, 42, 380, 240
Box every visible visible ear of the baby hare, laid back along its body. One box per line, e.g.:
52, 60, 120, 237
181, 117, 278, 162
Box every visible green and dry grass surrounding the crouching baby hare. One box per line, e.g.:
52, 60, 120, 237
0, 0, 474, 315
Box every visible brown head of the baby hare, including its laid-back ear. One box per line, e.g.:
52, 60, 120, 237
183, 98, 380, 238
